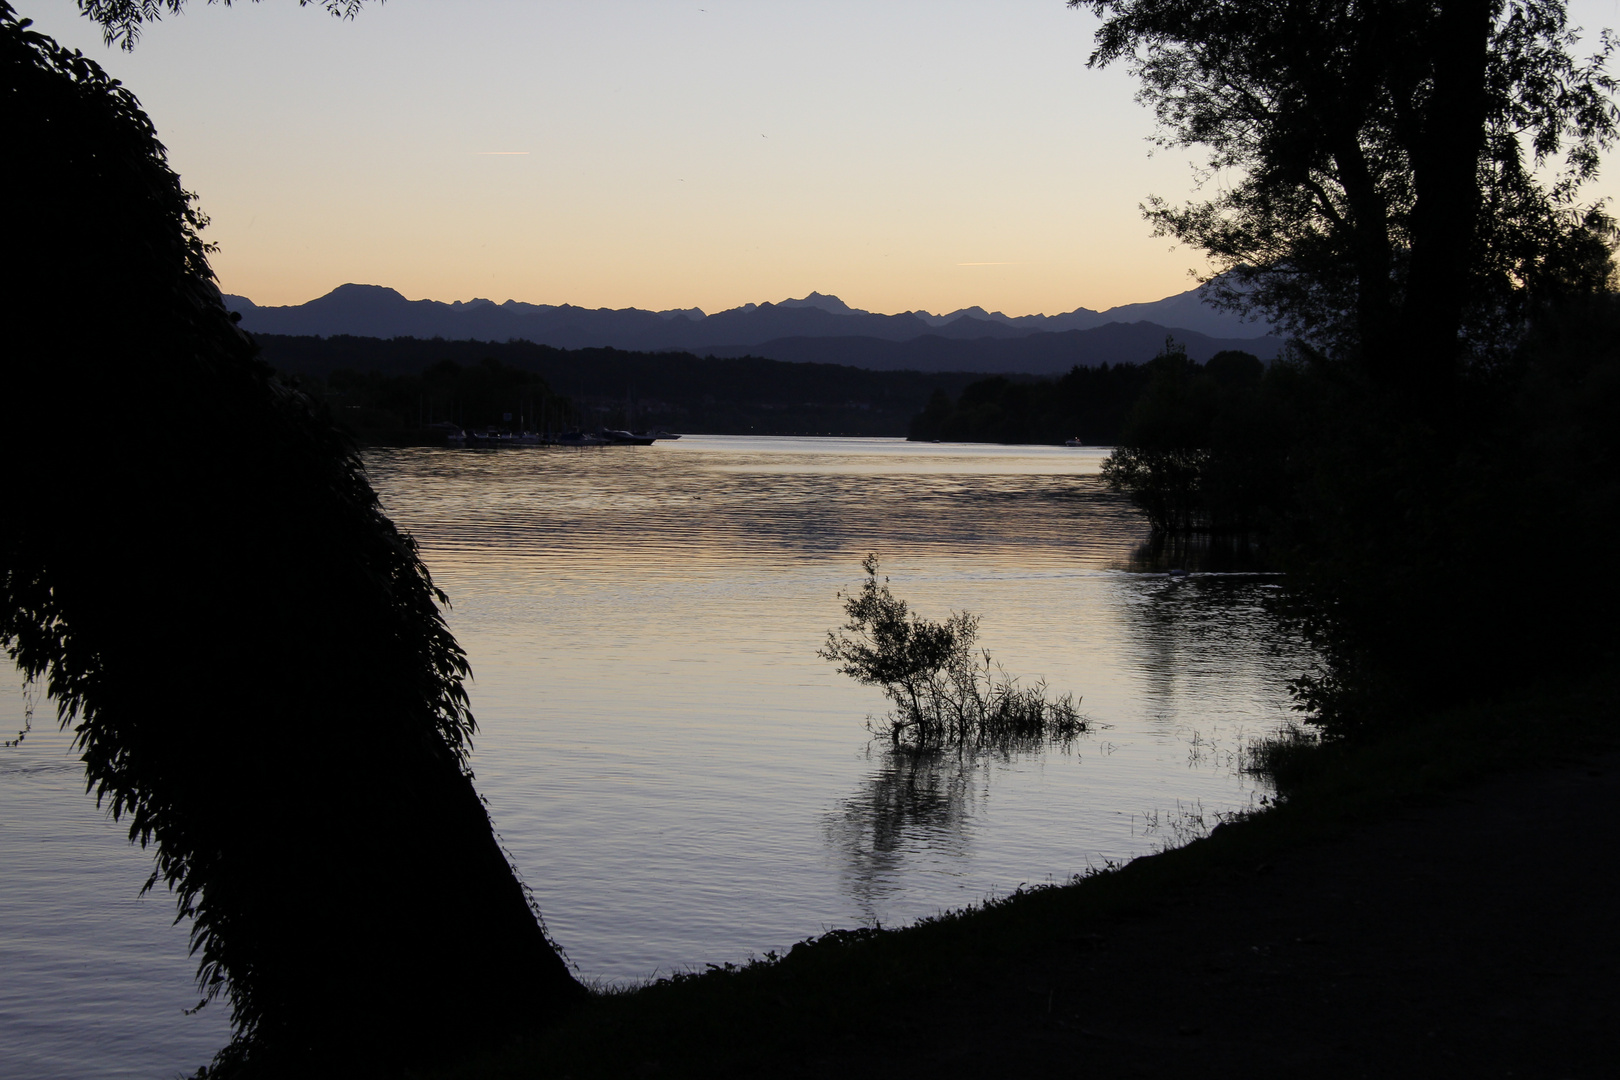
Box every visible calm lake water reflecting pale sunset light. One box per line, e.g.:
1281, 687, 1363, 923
0, 437, 1301, 1077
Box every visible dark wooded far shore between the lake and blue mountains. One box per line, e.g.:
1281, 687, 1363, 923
288, 344, 1205, 445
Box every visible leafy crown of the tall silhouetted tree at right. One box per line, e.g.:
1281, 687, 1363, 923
1069, 0, 1617, 397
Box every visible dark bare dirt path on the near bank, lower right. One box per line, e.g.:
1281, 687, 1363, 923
835, 755, 1620, 1077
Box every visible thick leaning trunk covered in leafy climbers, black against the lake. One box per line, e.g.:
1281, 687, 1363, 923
0, 0, 583, 1075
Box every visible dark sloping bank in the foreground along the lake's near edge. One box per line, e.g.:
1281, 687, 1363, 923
443, 678, 1620, 1077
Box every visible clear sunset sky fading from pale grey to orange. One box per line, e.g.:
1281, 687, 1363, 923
15, 0, 1620, 316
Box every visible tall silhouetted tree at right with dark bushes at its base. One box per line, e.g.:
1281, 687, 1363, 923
1071, 0, 1620, 733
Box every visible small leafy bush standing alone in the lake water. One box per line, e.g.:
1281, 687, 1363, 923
816, 555, 1087, 750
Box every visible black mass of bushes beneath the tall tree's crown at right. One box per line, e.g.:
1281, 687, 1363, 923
1272, 295, 1620, 733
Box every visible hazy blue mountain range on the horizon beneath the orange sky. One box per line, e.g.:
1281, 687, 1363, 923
225, 285, 1281, 374
